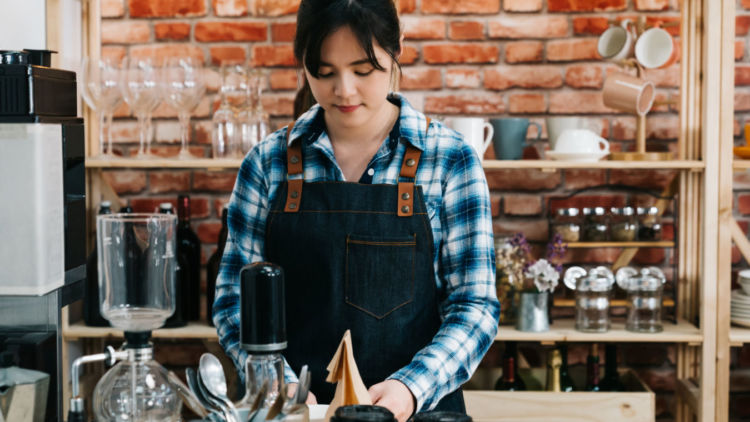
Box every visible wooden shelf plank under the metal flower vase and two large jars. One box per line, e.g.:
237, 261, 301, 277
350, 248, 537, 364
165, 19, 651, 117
495, 319, 703, 345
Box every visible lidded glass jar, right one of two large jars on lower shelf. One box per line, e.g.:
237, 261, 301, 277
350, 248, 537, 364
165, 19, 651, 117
615, 267, 666, 333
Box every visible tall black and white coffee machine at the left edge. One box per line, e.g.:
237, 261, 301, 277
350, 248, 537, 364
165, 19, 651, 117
0, 50, 86, 421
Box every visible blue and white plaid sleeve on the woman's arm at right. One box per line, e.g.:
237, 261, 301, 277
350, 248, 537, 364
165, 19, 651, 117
389, 144, 500, 411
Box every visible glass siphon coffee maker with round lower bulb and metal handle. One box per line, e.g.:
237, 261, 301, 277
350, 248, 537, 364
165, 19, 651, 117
68, 214, 182, 422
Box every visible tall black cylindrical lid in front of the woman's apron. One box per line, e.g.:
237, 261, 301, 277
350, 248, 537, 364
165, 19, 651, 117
240, 262, 286, 354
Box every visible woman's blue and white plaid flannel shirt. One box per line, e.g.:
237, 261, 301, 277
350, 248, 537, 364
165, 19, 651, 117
213, 94, 500, 411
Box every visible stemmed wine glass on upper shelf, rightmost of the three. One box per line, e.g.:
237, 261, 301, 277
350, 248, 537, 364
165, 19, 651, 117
163, 57, 206, 160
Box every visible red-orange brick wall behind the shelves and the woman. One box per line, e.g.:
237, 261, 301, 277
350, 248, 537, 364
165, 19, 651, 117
102, 0, 688, 418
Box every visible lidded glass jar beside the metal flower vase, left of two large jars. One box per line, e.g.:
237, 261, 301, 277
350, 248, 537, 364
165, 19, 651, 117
563, 266, 615, 333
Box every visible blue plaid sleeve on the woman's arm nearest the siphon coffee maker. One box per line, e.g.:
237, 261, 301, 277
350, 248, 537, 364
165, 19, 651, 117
213, 140, 297, 383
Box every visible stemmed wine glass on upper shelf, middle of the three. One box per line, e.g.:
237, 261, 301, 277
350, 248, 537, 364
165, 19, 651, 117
123, 58, 161, 159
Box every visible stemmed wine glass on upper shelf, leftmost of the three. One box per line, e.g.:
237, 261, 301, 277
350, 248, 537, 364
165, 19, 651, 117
81, 57, 122, 159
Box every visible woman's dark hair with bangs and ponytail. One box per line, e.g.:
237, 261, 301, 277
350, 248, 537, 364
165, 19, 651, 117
294, 0, 401, 118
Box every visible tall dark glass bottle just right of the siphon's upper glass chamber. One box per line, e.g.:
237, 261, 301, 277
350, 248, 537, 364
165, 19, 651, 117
177, 195, 201, 321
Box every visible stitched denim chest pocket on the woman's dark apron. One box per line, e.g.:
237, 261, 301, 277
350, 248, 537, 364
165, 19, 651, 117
344, 234, 417, 319
